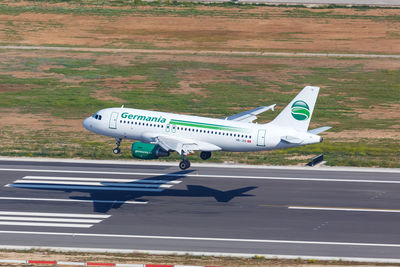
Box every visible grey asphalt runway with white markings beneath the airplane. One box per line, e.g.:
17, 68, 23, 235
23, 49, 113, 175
0, 160, 400, 260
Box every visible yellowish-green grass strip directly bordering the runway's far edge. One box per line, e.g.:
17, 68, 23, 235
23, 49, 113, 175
0, 129, 400, 168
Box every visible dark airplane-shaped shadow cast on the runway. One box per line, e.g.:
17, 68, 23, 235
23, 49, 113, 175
12, 170, 257, 213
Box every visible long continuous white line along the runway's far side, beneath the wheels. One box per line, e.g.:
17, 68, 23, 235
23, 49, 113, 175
0, 168, 400, 184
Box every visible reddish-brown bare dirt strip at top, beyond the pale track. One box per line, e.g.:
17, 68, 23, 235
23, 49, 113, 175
0, 1, 400, 54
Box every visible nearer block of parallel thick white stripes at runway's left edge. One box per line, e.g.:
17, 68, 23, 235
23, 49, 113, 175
0, 211, 111, 228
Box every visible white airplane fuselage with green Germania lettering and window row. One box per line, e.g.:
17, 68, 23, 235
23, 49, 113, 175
83, 108, 322, 152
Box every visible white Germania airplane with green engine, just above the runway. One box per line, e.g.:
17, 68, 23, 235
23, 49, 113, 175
83, 86, 331, 170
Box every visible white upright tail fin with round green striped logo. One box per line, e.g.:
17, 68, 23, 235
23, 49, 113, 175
271, 86, 319, 132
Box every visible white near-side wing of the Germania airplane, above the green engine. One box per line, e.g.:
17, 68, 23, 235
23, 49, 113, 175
154, 136, 221, 155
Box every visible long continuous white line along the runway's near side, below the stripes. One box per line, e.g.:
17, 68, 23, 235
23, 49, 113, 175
0, 231, 400, 248
